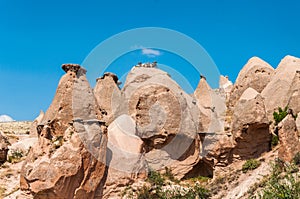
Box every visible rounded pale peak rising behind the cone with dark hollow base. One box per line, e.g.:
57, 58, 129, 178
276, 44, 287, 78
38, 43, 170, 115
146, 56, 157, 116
229, 57, 274, 107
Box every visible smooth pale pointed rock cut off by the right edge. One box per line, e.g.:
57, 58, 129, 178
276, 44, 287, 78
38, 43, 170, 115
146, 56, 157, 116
261, 56, 300, 121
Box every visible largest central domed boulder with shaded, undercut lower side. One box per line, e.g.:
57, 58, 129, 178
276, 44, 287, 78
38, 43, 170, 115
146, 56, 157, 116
122, 67, 200, 178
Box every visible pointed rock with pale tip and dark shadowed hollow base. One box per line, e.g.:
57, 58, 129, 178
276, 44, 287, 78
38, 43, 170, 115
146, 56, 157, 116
232, 88, 271, 159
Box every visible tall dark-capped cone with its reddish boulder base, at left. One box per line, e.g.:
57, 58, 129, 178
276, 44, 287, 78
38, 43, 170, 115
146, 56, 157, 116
20, 64, 107, 198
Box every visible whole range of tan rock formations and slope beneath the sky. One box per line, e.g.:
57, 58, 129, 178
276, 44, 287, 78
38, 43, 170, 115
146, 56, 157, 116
0, 56, 300, 198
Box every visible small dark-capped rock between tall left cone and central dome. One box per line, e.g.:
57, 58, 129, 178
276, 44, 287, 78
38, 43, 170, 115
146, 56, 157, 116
94, 73, 123, 125
